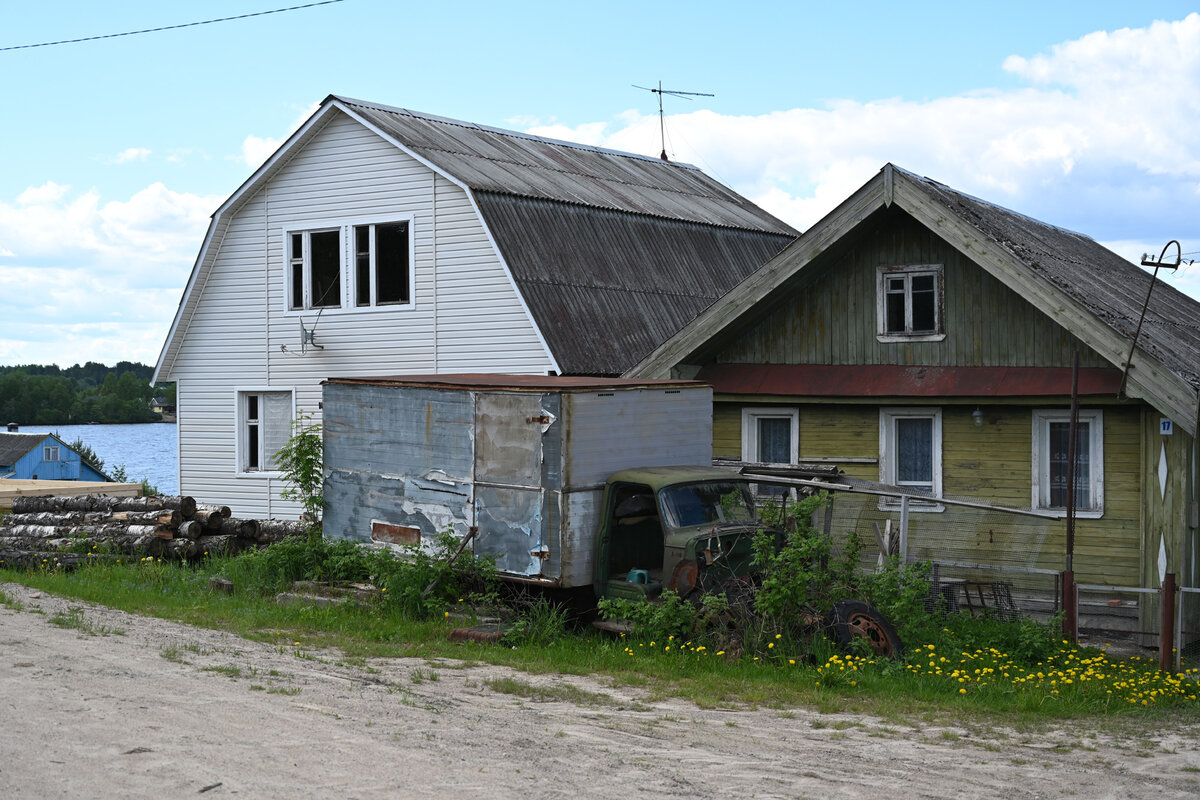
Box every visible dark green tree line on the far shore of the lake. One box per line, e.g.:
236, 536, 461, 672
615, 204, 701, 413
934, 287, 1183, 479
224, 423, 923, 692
0, 361, 175, 426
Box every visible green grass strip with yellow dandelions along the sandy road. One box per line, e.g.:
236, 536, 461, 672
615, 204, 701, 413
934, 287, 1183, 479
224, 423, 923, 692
0, 559, 1200, 730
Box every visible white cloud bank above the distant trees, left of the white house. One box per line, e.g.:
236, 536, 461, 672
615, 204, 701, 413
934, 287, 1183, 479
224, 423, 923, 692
0, 184, 221, 363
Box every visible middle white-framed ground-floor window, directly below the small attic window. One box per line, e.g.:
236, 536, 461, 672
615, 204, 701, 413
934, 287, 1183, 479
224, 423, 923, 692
880, 408, 943, 511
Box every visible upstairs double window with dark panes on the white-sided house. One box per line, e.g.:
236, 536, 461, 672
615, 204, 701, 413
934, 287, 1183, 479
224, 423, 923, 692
283, 216, 413, 311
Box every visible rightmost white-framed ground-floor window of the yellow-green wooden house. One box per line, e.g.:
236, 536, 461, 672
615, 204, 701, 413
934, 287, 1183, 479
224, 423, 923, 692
1033, 409, 1104, 517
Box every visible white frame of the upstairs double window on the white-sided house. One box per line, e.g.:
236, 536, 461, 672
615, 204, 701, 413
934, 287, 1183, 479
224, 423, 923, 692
280, 212, 416, 317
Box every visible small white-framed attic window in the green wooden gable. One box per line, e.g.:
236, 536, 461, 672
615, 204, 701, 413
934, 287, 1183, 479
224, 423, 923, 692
876, 264, 946, 342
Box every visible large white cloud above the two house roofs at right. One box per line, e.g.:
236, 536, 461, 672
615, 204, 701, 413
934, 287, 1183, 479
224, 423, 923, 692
533, 14, 1200, 244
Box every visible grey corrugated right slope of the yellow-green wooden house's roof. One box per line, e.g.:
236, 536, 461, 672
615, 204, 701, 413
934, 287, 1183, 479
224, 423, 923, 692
896, 170, 1200, 389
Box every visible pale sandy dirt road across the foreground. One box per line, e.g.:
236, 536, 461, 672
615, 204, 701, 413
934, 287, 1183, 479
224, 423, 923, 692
0, 584, 1200, 800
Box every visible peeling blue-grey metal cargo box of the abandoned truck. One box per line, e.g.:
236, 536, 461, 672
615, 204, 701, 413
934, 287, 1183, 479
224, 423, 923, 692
323, 374, 713, 588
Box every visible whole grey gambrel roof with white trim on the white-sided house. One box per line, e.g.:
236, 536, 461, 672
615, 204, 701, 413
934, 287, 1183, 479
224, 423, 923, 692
155, 95, 797, 379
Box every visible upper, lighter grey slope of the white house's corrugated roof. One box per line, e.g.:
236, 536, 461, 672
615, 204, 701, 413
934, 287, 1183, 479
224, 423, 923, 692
331, 96, 797, 236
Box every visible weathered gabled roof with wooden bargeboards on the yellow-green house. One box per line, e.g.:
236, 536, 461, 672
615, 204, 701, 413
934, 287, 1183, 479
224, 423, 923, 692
626, 164, 1200, 432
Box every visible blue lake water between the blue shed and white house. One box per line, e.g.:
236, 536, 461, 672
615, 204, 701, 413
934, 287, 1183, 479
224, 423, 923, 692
19, 422, 179, 494
